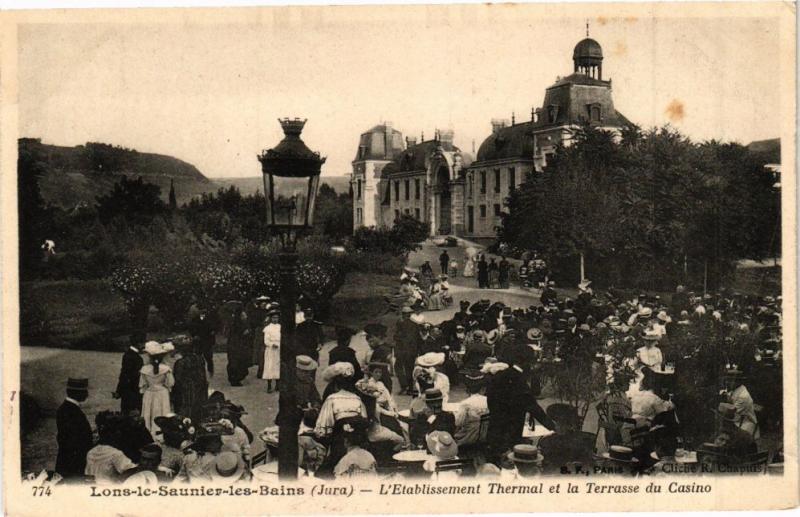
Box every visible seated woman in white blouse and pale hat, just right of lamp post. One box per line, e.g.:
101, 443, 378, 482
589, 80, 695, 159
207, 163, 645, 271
314, 362, 367, 477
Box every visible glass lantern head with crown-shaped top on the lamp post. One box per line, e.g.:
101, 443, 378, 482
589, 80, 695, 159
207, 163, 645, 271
258, 118, 325, 246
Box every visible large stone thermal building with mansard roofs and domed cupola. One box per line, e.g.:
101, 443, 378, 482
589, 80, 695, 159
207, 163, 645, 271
352, 37, 629, 238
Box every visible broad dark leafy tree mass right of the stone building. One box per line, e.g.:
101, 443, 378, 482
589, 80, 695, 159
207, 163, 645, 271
498, 126, 780, 288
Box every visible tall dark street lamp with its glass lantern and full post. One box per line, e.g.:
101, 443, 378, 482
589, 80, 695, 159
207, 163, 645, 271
258, 118, 325, 480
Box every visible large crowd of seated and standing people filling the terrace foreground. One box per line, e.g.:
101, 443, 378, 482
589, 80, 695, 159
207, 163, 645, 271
48, 258, 782, 484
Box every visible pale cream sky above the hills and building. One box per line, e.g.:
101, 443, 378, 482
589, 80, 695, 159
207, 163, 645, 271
18, 5, 781, 177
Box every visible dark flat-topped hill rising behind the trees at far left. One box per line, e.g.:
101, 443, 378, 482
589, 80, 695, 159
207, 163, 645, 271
19, 138, 216, 208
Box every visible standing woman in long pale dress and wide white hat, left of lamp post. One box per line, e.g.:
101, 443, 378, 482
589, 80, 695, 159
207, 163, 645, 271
139, 341, 175, 434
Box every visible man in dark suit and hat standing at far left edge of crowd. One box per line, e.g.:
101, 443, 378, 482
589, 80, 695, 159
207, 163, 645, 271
56, 378, 93, 480
